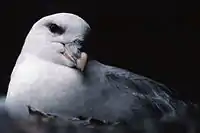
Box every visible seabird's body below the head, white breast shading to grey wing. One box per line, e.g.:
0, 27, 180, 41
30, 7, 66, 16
6, 51, 185, 121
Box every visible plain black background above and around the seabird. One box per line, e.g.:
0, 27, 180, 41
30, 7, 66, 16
0, 0, 200, 102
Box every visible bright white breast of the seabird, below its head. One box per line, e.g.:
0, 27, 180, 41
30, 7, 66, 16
6, 55, 84, 118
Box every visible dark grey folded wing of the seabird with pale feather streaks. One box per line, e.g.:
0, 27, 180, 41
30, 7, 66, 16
105, 66, 186, 119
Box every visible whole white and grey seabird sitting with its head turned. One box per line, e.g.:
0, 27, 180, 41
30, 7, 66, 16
5, 13, 199, 133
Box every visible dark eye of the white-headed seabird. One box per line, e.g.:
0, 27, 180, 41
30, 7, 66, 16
47, 23, 65, 35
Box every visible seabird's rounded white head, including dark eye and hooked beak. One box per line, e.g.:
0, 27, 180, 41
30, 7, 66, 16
22, 13, 90, 70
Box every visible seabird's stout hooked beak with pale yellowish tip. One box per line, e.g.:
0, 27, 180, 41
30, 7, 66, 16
62, 43, 88, 71
